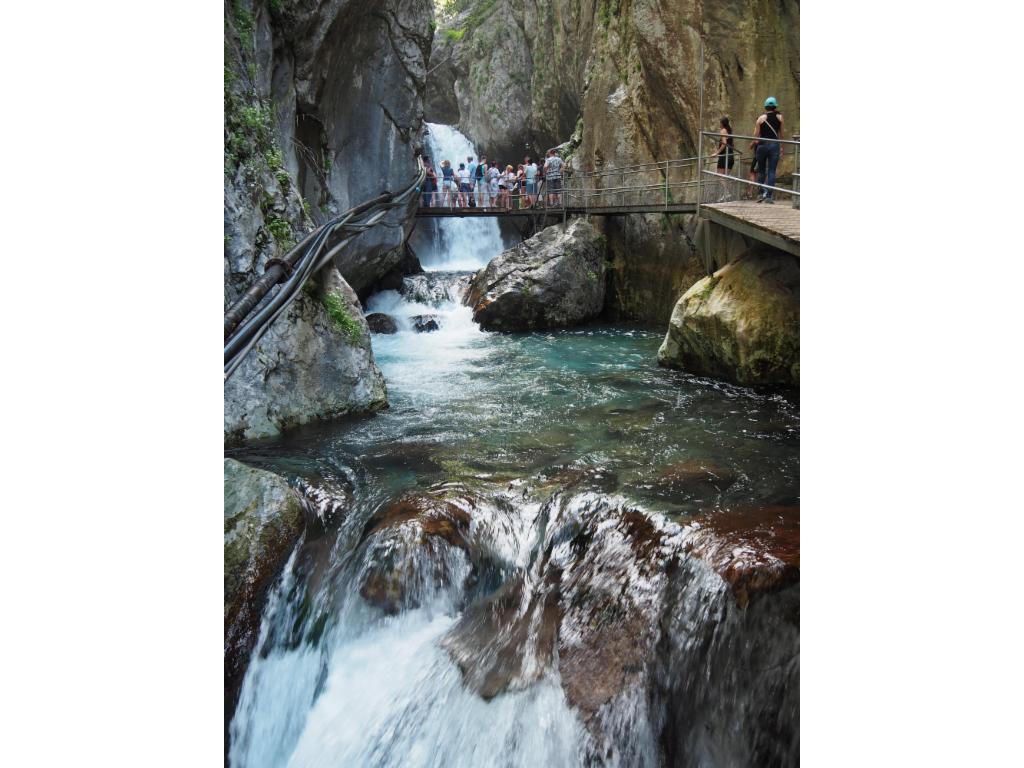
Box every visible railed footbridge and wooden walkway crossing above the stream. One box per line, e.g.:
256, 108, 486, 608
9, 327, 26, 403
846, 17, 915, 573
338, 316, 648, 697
416, 131, 800, 256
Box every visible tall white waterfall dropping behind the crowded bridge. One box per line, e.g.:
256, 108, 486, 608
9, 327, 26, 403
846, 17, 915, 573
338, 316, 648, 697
419, 123, 503, 271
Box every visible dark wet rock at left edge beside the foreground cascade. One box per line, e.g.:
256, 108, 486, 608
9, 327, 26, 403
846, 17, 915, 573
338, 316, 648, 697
224, 459, 304, 711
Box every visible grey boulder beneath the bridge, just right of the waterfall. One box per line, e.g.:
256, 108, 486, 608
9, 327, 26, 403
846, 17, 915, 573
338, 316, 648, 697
466, 218, 605, 331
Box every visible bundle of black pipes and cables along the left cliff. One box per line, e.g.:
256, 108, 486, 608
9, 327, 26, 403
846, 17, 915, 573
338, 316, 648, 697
224, 163, 427, 381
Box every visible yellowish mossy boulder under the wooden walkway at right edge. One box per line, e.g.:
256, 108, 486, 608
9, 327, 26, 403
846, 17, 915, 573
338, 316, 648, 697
657, 248, 800, 386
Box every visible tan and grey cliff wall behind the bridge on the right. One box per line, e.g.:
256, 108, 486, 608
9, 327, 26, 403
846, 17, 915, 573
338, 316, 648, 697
425, 0, 800, 327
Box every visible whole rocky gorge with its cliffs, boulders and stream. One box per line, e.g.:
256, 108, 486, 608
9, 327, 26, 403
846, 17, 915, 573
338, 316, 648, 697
224, 0, 800, 767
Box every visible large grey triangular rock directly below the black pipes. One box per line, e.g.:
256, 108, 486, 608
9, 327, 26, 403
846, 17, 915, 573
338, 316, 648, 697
224, 268, 387, 443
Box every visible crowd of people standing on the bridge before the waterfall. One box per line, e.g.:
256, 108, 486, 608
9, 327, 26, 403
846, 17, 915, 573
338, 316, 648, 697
420, 150, 564, 211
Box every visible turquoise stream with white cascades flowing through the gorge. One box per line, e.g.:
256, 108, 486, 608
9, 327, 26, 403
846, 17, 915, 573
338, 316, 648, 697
229, 125, 799, 768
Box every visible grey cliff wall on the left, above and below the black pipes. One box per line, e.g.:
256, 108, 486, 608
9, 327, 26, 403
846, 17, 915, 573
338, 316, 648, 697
224, 0, 433, 440
